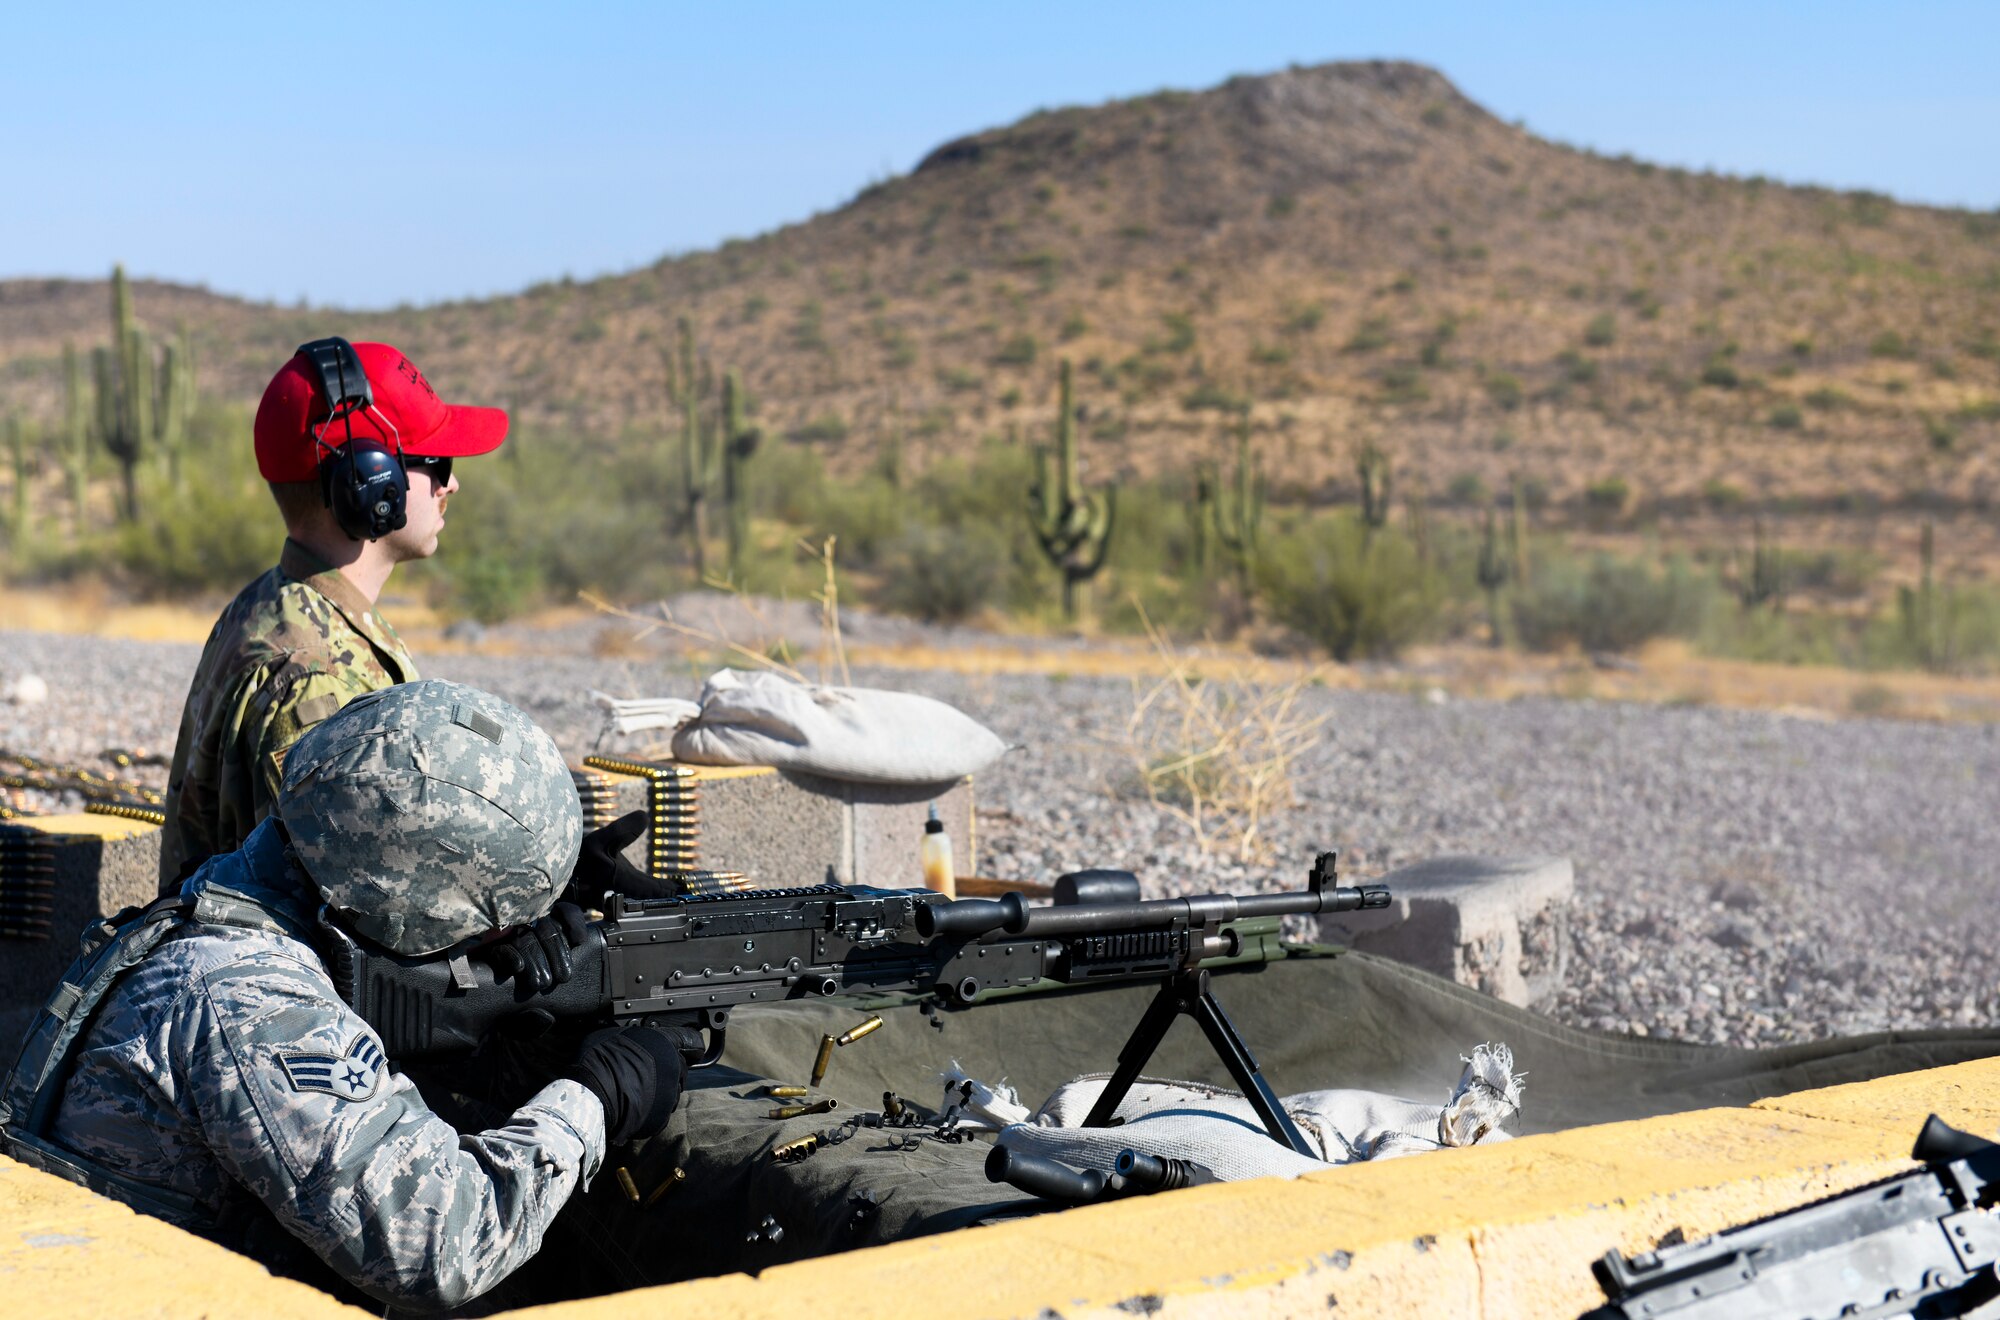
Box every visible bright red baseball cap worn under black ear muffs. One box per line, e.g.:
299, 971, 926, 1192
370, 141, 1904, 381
256, 344, 506, 482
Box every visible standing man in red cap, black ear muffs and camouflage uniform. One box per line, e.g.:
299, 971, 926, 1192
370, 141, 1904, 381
160, 338, 506, 894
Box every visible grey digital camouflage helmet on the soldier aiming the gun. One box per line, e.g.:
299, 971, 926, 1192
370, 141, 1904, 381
278, 678, 584, 954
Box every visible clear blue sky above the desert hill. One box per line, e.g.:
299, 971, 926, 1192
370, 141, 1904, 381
0, 0, 2000, 308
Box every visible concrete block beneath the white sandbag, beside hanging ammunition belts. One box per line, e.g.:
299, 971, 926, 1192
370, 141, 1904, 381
584, 766, 978, 888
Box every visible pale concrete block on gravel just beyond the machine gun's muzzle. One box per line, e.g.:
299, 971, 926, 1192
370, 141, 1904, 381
1320, 856, 1576, 1008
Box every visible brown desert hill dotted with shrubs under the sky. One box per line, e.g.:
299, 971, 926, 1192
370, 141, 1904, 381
0, 62, 2000, 514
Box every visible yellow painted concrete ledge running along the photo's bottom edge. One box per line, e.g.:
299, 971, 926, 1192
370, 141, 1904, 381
0, 1060, 2000, 1320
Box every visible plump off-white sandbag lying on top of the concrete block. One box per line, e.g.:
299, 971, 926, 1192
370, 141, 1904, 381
674, 670, 1006, 784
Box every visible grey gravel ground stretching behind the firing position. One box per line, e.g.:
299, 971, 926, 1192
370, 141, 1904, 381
0, 632, 2000, 1044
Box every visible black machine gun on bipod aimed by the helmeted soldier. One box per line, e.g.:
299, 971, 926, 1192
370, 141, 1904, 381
322, 852, 1390, 1154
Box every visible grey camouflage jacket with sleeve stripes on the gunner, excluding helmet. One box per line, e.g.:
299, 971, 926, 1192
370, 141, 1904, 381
52, 822, 604, 1308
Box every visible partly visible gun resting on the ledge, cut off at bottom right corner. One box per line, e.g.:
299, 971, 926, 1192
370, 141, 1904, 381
1586, 1114, 2000, 1320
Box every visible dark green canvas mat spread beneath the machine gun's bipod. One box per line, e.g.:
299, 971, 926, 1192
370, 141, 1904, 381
516, 950, 2000, 1300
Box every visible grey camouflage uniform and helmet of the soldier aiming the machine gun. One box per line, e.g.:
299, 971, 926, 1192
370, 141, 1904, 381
35, 680, 606, 1310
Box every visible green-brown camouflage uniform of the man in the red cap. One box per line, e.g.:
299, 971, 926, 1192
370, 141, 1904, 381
160, 538, 416, 894
